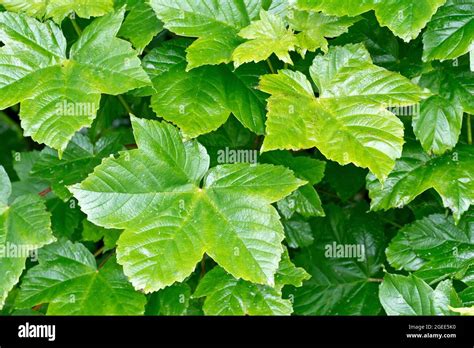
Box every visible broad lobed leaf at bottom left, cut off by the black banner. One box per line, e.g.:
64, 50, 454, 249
17, 241, 146, 315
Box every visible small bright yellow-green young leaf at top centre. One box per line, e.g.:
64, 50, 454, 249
232, 11, 298, 68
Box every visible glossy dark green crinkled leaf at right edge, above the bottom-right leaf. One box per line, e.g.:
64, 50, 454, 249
387, 214, 474, 283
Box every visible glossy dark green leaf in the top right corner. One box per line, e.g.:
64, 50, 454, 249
423, 0, 474, 61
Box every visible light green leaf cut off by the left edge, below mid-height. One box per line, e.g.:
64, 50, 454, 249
0, 166, 55, 308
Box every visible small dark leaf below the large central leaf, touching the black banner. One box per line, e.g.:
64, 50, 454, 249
145, 283, 191, 316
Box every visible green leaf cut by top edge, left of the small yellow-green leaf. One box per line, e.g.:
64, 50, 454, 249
150, 0, 262, 70
